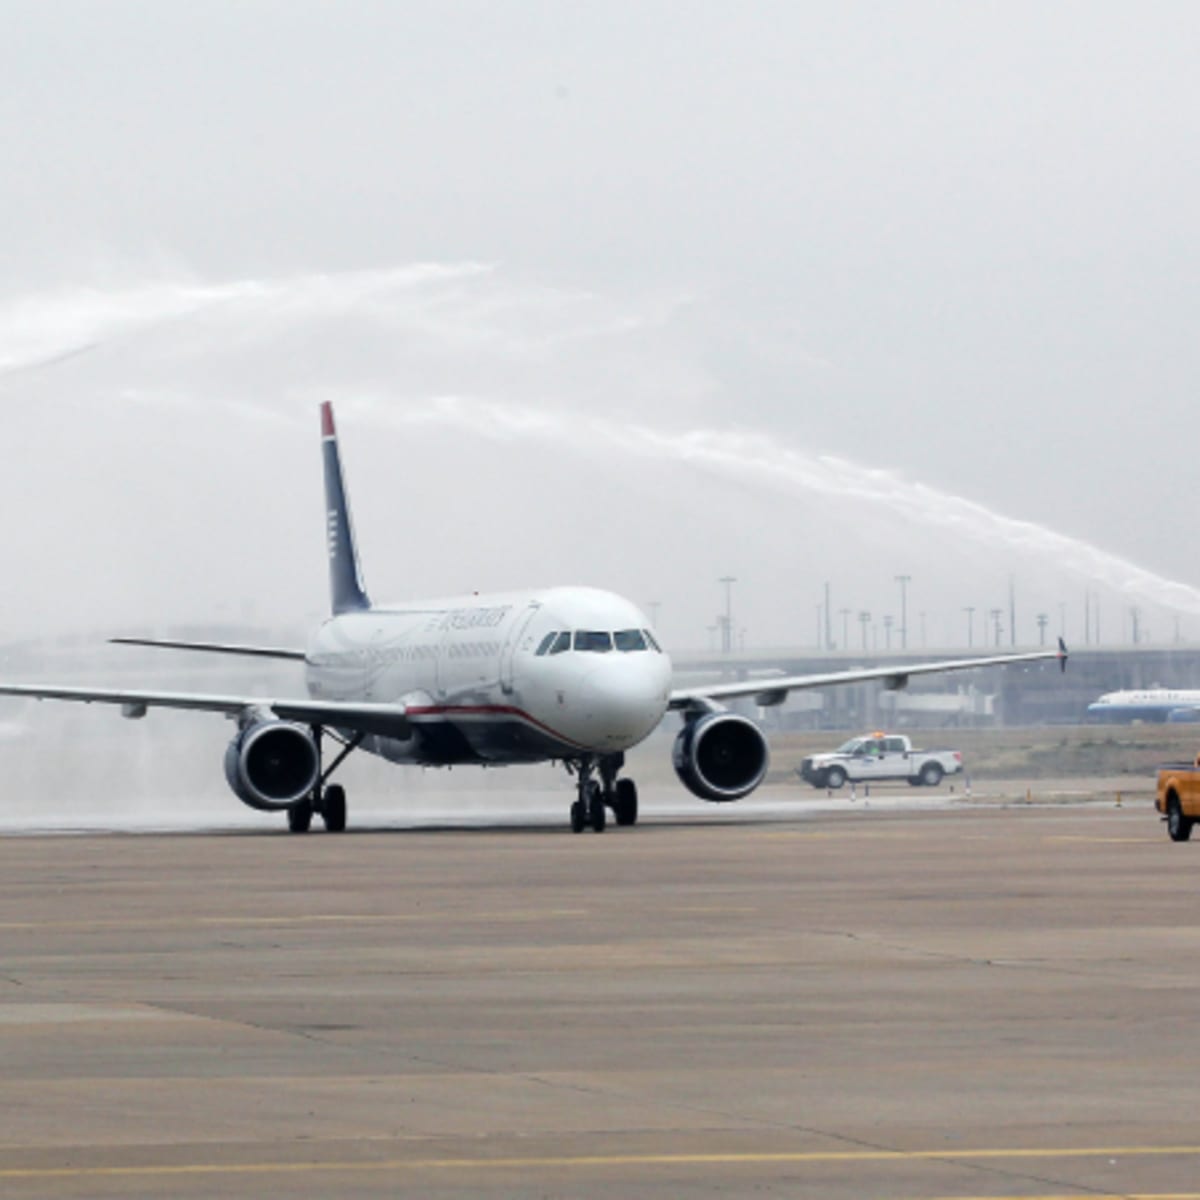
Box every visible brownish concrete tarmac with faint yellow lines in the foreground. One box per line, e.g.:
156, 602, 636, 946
0, 796, 1200, 1200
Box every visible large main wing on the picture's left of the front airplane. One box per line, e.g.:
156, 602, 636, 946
0, 683, 409, 738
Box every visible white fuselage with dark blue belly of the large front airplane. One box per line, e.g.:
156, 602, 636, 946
306, 588, 671, 764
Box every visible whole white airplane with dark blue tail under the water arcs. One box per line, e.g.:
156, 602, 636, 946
0, 403, 1067, 833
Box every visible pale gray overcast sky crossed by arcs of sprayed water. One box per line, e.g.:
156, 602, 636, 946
0, 0, 1200, 647
